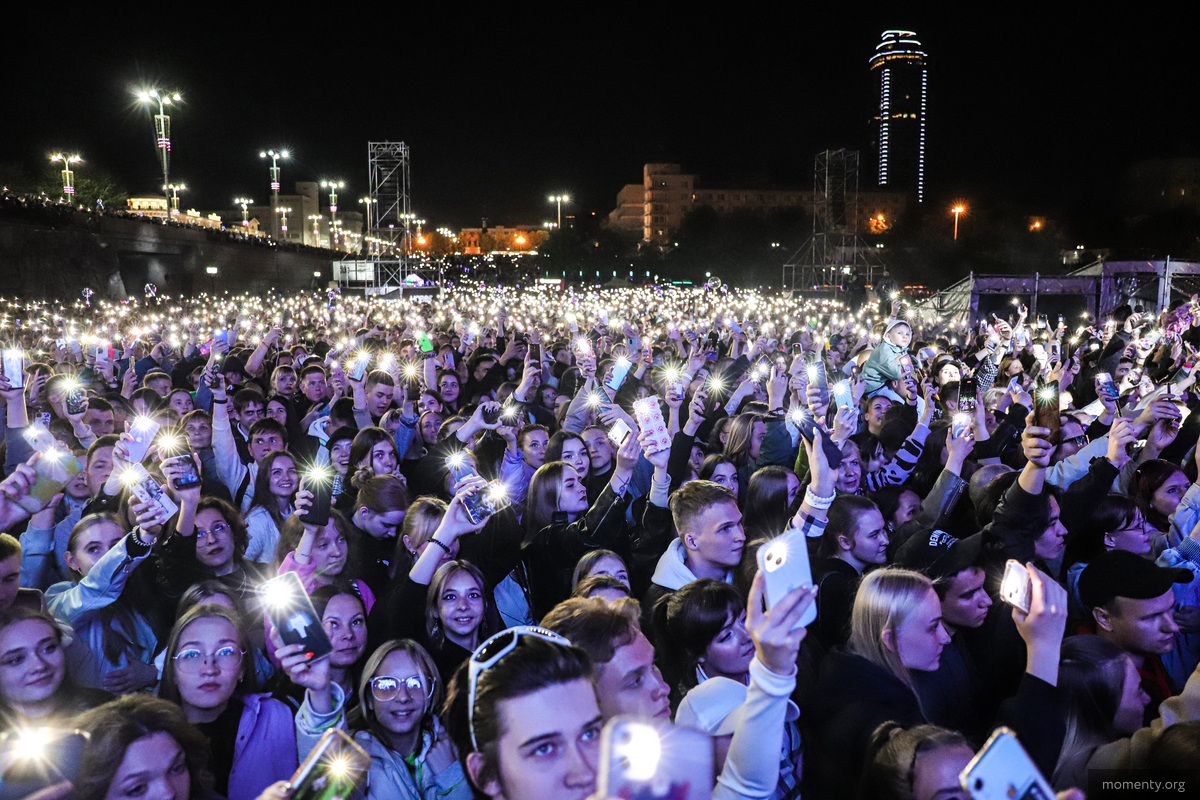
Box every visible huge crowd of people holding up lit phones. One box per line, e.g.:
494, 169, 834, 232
0, 285, 1200, 800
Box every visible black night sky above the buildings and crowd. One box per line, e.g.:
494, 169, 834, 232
0, 9, 1200, 227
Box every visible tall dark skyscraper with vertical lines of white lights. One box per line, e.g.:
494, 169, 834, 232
870, 30, 929, 203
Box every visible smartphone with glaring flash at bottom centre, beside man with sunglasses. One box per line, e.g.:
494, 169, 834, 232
596, 716, 713, 800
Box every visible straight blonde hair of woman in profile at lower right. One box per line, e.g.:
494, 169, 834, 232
850, 567, 934, 688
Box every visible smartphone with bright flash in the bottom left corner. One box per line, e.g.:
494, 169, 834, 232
0, 728, 90, 800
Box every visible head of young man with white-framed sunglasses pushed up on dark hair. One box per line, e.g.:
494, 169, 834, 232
442, 625, 604, 800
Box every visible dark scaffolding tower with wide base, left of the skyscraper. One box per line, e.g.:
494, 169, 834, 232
782, 149, 880, 291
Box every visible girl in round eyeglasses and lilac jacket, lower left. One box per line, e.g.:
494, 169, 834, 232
158, 603, 342, 800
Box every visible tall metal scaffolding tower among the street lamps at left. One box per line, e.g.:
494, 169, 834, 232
365, 142, 413, 290
